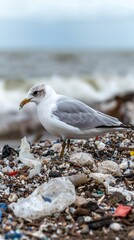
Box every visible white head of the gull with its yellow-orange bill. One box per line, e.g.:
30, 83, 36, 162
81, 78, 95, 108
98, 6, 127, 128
20, 83, 54, 109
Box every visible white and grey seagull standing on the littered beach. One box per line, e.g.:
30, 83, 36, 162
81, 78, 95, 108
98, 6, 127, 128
20, 83, 134, 158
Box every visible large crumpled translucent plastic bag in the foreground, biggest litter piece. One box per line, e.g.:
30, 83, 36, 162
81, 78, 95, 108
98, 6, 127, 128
9, 178, 76, 219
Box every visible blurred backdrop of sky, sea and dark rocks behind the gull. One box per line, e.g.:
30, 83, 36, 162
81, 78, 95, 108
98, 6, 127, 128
0, 0, 134, 147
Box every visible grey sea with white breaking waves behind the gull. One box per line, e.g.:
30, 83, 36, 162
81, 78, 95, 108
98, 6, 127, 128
0, 50, 134, 113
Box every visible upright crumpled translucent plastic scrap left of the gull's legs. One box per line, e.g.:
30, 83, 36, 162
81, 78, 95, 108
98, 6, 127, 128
19, 137, 42, 178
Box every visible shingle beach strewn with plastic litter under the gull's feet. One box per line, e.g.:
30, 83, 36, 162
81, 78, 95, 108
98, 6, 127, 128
0, 131, 134, 240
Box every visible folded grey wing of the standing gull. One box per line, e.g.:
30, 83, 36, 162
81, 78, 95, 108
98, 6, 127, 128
52, 96, 122, 130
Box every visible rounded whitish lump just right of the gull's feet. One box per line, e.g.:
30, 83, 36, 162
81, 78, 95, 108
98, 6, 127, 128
69, 152, 94, 166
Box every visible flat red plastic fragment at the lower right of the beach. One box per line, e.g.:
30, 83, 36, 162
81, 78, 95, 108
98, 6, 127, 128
113, 204, 132, 217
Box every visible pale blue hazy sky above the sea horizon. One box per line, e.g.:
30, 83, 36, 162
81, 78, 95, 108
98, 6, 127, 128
0, 0, 134, 50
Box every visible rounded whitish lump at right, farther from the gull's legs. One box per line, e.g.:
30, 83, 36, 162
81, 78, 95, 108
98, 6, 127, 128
97, 160, 122, 176
